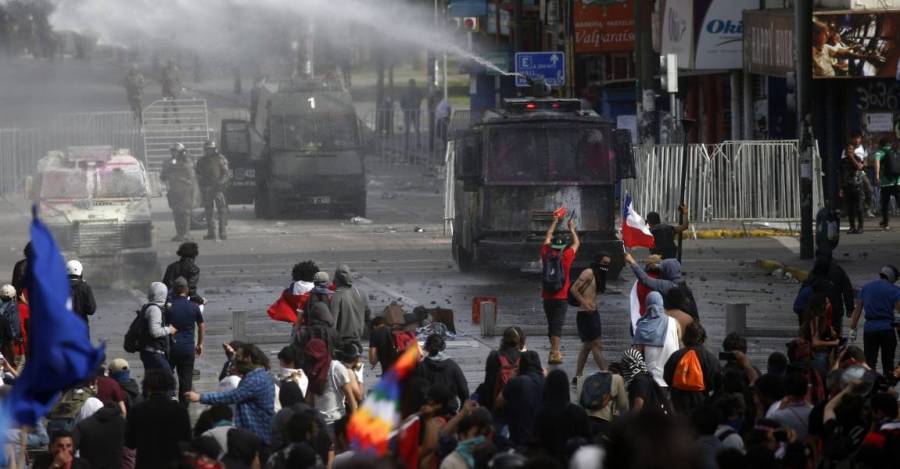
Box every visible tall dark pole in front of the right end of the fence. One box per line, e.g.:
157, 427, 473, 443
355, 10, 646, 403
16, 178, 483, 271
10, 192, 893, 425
794, 0, 818, 259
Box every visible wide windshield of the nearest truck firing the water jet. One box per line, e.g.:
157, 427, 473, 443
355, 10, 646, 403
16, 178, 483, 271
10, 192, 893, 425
487, 125, 615, 183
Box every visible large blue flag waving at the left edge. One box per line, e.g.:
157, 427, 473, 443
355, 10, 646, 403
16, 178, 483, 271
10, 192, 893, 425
4, 207, 104, 426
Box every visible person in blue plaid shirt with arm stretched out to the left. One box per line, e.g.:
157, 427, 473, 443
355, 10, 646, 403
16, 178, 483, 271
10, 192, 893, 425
185, 344, 275, 444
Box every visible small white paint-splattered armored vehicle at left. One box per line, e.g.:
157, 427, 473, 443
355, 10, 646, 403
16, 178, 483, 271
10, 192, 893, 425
29, 146, 159, 284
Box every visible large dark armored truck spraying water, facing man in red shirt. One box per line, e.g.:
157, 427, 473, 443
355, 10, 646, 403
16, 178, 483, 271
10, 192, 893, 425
447, 97, 634, 274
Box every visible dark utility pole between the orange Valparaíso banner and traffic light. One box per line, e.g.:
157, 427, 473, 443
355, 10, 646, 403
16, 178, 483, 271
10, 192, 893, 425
634, 0, 656, 143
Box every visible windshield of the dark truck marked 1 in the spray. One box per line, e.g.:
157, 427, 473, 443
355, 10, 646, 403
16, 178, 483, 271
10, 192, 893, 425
269, 112, 358, 152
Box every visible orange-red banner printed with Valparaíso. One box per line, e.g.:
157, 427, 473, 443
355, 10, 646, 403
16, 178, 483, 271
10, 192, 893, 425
575, 0, 634, 54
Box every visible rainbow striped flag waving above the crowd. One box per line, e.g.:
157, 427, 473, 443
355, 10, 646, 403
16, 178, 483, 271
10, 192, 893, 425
347, 346, 419, 456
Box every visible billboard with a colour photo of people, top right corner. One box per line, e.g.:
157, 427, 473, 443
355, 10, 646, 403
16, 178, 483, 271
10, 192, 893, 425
812, 11, 900, 79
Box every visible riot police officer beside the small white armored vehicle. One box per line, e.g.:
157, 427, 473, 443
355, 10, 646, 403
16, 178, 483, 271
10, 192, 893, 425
159, 143, 197, 242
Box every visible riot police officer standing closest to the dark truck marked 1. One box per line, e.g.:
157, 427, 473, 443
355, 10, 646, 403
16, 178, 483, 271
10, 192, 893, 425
197, 140, 230, 240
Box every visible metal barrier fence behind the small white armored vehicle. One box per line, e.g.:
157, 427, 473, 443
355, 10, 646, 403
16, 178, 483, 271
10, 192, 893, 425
0, 111, 143, 194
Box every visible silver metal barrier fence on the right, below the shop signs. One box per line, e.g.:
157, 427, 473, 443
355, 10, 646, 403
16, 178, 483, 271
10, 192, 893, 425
622, 140, 823, 222
